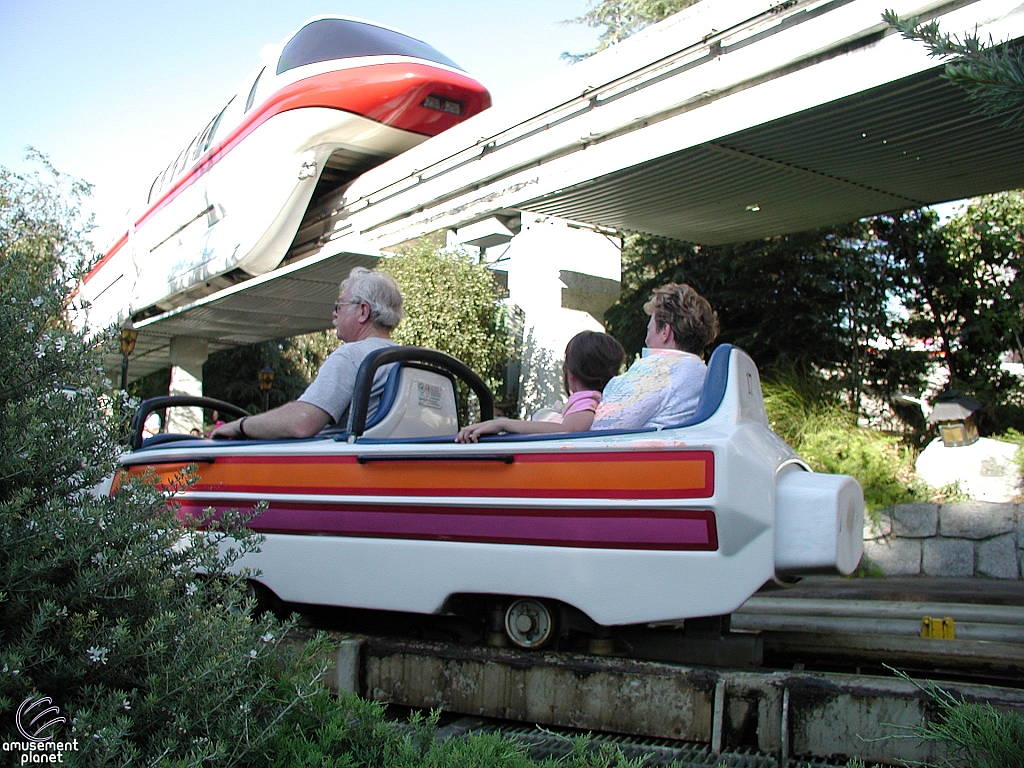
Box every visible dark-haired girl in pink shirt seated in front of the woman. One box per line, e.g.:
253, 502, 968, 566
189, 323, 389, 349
455, 331, 626, 442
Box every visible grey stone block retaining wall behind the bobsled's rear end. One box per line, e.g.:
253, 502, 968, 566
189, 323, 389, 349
864, 502, 1024, 579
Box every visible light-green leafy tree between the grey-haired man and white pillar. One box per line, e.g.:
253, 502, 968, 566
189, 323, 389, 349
379, 241, 510, 399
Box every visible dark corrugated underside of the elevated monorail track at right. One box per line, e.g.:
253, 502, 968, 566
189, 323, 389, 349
521, 69, 1024, 245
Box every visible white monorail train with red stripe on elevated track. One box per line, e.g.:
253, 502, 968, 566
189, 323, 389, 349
81, 16, 490, 328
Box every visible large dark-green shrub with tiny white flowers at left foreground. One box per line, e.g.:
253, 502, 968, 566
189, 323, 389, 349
0, 159, 326, 766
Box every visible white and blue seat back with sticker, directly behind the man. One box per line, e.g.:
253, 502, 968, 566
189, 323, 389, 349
362, 362, 459, 438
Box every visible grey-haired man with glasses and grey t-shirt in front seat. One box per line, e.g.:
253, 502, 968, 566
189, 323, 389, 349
211, 266, 402, 440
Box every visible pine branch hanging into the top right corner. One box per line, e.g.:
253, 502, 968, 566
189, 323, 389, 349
882, 10, 1024, 126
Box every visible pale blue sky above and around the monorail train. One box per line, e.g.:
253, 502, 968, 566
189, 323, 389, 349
0, 0, 597, 249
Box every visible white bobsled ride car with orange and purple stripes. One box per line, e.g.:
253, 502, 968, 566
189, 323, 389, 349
121, 344, 863, 648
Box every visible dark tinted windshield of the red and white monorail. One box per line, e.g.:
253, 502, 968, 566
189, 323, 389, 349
278, 18, 462, 75
